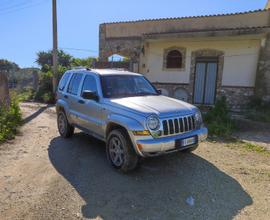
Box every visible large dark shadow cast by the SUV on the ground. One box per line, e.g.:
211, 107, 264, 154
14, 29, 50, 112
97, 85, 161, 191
49, 133, 252, 219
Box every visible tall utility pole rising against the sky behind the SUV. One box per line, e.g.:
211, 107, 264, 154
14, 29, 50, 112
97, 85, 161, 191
52, 0, 58, 93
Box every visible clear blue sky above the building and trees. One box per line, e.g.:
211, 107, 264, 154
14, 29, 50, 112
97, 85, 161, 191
0, 0, 267, 67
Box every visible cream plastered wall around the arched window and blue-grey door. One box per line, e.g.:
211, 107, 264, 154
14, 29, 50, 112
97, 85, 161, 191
141, 38, 260, 87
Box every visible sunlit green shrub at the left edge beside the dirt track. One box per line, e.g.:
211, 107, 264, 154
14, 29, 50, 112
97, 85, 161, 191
0, 99, 21, 143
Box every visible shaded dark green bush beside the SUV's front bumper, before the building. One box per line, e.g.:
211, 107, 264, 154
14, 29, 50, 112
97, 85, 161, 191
204, 97, 234, 137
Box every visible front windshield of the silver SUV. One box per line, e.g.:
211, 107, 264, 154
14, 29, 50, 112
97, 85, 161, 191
101, 75, 158, 98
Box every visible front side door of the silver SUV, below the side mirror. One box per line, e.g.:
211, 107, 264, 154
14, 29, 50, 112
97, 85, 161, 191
79, 74, 103, 137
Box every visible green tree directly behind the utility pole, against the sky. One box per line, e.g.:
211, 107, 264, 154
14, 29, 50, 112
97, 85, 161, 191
36, 50, 72, 72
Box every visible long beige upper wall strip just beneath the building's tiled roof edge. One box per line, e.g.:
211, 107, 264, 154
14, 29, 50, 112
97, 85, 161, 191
105, 10, 270, 38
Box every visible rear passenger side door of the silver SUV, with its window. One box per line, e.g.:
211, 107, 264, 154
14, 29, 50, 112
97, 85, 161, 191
64, 72, 83, 126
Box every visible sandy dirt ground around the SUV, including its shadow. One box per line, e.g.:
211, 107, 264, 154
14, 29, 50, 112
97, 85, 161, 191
0, 103, 270, 220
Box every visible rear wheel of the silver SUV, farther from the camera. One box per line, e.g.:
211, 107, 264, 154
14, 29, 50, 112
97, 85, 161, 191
57, 111, 74, 138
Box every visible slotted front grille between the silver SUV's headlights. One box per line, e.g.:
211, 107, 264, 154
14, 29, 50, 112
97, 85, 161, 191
162, 115, 195, 135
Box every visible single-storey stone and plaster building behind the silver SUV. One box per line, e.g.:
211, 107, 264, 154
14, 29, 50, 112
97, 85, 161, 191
99, 3, 270, 110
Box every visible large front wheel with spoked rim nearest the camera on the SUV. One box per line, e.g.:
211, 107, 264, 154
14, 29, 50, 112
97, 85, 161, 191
106, 129, 139, 173
